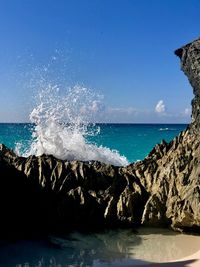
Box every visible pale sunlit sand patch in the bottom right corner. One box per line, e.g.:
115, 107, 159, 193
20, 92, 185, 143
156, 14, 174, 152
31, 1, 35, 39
124, 229, 200, 267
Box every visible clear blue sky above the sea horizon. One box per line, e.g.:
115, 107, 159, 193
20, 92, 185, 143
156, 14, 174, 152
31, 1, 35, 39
0, 0, 200, 123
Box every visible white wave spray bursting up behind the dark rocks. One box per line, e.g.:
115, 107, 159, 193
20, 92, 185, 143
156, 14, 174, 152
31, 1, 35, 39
22, 85, 128, 165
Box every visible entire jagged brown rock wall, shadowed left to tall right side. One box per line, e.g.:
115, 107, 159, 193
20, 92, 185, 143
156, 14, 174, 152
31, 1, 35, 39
0, 40, 200, 237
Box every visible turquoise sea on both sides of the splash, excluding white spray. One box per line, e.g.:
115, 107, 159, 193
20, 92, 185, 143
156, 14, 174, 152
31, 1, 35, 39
0, 123, 187, 162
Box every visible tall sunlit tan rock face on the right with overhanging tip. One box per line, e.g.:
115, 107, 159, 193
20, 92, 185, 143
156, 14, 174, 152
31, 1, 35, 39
124, 40, 200, 232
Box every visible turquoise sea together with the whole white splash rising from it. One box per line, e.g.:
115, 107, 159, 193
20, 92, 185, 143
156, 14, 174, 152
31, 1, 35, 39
0, 85, 187, 166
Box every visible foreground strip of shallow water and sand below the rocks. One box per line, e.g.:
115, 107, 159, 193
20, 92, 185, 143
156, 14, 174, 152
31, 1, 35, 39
0, 228, 200, 267
